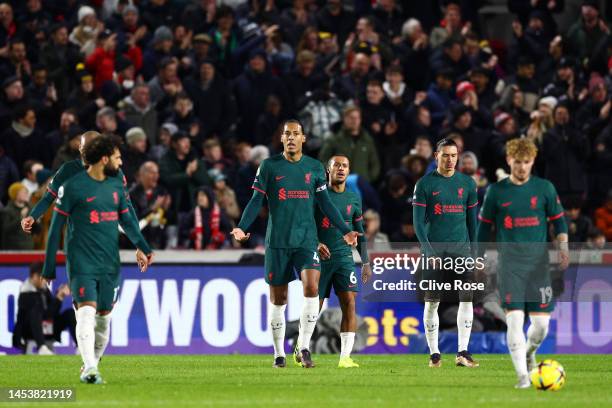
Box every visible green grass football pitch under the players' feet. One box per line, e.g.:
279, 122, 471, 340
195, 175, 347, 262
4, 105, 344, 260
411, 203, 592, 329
0, 355, 612, 408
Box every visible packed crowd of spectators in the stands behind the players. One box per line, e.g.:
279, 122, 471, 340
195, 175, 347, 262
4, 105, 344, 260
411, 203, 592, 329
0, 0, 612, 249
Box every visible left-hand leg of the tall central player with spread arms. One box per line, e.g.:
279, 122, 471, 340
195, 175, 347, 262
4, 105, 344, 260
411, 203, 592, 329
264, 248, 294, 368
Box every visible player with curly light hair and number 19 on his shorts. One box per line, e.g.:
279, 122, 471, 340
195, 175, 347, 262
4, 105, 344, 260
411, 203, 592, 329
478, 138, 569, 388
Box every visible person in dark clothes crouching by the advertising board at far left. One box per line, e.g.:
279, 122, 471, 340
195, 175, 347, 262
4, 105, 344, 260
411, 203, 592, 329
13, 263, 76, 355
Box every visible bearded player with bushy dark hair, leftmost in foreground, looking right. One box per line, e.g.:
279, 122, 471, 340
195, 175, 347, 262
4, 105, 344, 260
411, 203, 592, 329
43, 135, 153, 384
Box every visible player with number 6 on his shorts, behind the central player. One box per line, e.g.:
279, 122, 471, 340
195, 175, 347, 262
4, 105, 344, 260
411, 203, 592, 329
315, 155, 372, 368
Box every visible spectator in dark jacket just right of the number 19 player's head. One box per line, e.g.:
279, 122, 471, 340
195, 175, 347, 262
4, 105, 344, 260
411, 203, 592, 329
542, 103, 591, 203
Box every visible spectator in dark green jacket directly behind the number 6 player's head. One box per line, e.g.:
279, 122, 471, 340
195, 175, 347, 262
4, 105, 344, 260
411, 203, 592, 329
319, 107, 380, 183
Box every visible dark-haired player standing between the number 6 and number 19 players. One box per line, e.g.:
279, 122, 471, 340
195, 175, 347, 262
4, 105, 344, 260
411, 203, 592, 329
412, 139, 478, 367
